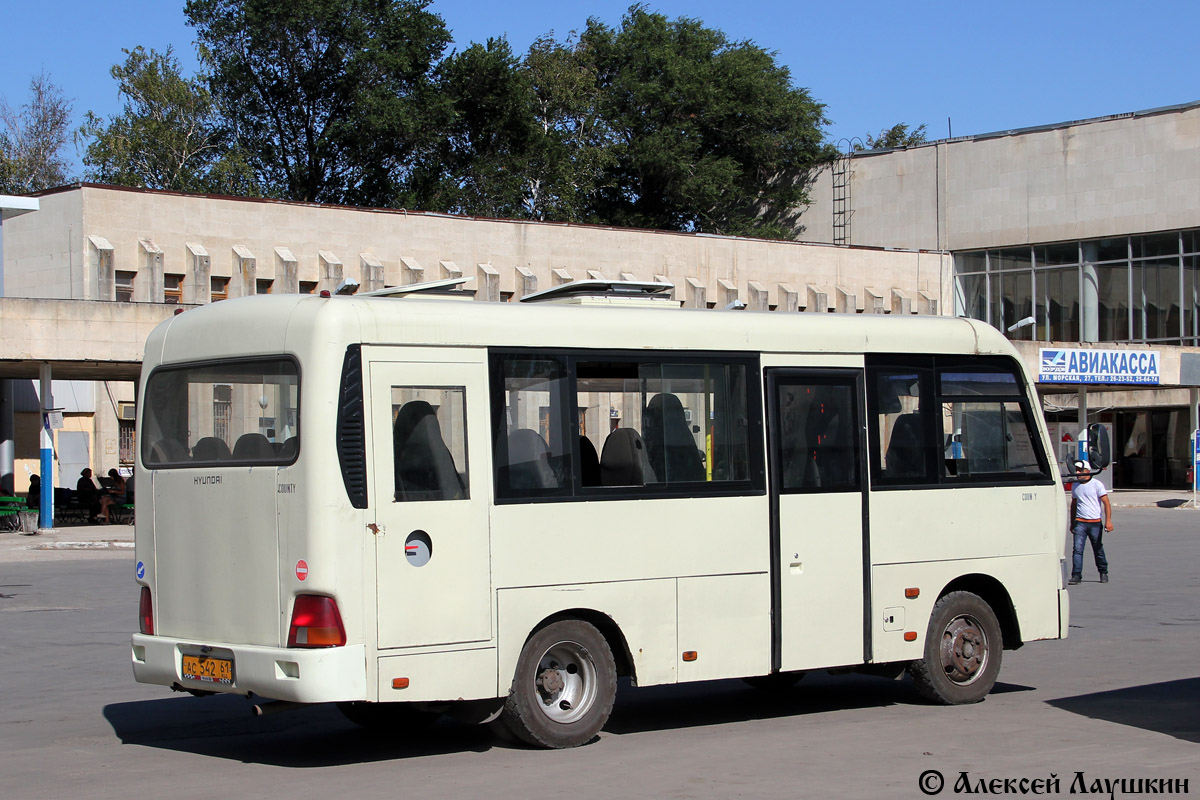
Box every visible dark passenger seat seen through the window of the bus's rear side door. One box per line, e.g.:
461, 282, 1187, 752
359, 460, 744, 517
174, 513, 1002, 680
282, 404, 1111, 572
392, 401, 467, 500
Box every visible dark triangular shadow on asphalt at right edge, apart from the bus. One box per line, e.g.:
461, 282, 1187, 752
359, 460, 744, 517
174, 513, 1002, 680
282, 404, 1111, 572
1046, 678, 1200, 742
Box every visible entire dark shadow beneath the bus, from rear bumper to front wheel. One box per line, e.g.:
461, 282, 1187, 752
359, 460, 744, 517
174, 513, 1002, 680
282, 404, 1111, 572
104, 674, 1030, 768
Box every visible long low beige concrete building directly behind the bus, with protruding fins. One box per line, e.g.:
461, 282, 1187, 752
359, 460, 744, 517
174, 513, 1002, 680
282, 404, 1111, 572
0, 185, 952, 491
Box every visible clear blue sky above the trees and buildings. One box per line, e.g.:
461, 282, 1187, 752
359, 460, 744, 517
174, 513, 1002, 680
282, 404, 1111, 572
0, 0, 1200, 172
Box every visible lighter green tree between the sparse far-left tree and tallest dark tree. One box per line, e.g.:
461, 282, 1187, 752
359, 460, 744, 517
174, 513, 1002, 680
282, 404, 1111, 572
79, 47, 258, 196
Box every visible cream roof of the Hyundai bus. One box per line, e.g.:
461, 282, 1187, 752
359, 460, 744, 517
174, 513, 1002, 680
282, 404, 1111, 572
146, 295, 1015, 363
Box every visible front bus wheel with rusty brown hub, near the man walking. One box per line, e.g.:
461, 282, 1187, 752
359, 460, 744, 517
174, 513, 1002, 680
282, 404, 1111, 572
908, 591, 1003, 705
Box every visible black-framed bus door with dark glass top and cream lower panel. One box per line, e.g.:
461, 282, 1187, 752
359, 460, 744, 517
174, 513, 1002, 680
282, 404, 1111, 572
767, 369, 870, 672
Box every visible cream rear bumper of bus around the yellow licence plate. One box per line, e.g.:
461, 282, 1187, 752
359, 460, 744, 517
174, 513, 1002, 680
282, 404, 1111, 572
132, 633, 367, 703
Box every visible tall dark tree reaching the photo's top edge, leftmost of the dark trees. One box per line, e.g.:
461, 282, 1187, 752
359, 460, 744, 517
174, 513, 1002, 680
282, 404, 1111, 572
185, 0, 450, 206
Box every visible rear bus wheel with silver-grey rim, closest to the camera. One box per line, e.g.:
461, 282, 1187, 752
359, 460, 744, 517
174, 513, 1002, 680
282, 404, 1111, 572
500, 619, 617, 748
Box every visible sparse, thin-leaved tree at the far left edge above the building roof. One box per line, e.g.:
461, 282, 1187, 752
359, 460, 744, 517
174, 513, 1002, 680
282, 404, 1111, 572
0, 72, 71, 194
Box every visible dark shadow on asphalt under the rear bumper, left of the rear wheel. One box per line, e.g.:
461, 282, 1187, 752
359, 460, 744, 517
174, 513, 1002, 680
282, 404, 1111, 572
104, 696, 499, 768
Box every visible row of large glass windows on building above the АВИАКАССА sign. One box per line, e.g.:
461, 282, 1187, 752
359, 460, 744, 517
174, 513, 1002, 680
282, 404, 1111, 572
954, 230, 1200, 344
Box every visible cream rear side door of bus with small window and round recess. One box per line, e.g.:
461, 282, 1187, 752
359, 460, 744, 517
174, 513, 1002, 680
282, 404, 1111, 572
364, 350, 492, 648
